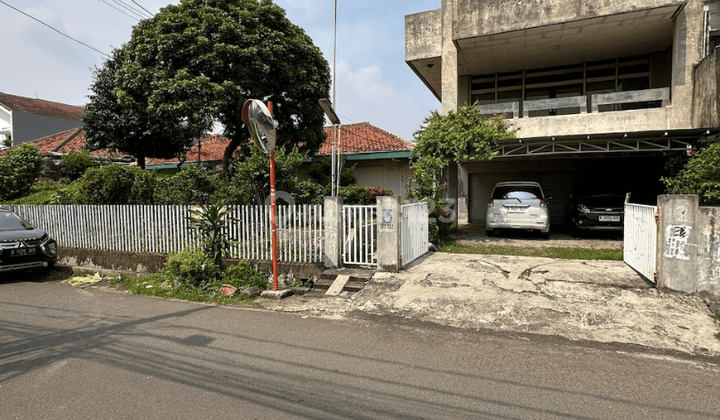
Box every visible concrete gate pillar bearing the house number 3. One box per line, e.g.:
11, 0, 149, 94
377, 197, 402, 273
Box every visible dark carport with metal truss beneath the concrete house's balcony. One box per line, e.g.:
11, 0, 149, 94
458, 129, 720, 226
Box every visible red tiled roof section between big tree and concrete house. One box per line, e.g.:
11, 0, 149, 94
317, 122, 413, 155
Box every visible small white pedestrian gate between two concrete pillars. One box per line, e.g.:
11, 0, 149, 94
342, 206, 377, 265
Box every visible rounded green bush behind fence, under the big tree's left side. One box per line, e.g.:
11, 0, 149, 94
75, 165, 156, 205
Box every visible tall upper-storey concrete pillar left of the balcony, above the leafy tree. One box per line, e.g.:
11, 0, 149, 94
442, 0, 458, 115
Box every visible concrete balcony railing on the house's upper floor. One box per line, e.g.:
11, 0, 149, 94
478, 88, 670, 119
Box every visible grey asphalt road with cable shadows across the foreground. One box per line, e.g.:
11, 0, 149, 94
0, 279, 720, 420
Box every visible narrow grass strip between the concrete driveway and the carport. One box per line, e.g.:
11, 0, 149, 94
440, 240, 623, 261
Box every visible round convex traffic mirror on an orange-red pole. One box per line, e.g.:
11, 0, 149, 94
242, 99, 278, 290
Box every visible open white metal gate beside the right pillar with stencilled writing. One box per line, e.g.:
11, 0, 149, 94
623, 203, 657, 281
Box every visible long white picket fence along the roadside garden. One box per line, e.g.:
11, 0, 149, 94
11, 205, 323, 263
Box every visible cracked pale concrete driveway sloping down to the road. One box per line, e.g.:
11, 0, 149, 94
260, 252, 720, 357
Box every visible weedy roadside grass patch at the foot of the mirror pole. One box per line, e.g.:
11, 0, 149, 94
122, 274, 258, 306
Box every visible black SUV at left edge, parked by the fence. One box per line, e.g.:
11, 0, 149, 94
0, 208, 57, 278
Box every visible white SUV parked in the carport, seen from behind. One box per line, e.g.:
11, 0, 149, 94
485, 181, 550, 238
